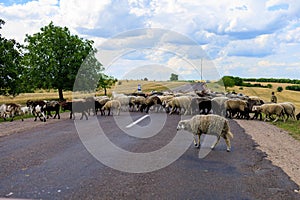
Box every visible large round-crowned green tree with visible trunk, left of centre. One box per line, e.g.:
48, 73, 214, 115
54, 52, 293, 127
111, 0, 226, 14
24, 22, 103, 100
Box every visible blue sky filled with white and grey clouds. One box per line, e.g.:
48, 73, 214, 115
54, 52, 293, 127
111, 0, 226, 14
0, 0, 300, 80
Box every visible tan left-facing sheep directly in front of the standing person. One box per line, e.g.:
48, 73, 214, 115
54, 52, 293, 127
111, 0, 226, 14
253, 103, 285, 122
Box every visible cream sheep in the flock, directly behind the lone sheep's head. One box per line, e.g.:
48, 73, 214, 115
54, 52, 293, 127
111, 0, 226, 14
166, 96, 191, 115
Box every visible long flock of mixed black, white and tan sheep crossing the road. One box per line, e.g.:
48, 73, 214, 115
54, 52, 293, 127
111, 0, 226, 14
0, 92, 300, 122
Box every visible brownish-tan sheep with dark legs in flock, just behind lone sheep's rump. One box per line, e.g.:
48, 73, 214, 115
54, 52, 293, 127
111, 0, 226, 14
225, 99, 250, 119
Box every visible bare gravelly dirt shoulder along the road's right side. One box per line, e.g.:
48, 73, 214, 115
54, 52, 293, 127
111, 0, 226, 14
235, 120, 300, 186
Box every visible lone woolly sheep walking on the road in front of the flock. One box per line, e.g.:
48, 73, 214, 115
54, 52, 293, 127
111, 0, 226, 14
177, 114, 233, 152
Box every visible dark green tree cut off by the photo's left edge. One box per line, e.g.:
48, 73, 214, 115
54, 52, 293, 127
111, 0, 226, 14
0, 19, 24, 96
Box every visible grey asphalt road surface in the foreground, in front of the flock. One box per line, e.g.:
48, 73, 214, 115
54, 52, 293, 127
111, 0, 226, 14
0, 113, 300, 199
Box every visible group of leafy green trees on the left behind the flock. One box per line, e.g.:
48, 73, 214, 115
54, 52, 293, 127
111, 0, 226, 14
0, 19, 117, 100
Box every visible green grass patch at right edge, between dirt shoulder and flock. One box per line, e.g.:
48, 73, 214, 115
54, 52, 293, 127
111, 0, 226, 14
270, 119, 300, 141
